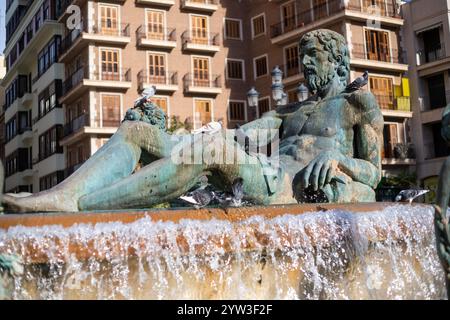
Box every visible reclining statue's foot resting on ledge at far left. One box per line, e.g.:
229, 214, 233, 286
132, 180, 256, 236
3, 192, 78, 213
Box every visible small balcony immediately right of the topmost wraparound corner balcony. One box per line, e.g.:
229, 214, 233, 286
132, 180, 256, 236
136, 25, 177, 50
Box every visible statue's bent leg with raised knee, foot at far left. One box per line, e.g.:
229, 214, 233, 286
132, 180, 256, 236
3, 121, 171, 212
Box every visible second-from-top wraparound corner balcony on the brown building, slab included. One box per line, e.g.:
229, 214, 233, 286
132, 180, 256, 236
59, 67, 131, 104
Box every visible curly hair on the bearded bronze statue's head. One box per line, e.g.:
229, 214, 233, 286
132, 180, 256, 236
300, 29, 350, 84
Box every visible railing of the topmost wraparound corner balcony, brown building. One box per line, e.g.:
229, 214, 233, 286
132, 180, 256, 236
59, 20, 130, 56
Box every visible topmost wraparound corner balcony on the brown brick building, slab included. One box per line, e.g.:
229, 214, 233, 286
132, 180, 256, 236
59, 21, 131, 62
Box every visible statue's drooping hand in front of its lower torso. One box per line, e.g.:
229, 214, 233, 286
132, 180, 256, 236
300, 151, 344, 191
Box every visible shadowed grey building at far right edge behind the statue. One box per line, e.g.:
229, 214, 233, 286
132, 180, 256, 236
402, 0, 450, 201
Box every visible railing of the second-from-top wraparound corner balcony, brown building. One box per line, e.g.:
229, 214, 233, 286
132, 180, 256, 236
63, 67, 131, 96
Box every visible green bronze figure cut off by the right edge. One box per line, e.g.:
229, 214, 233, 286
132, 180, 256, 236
434, 105, 450, 297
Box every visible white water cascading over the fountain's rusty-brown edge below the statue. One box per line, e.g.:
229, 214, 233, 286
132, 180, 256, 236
0, 206, 446, 299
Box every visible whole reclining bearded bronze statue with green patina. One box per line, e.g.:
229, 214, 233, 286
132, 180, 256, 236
4, 30, 383, 211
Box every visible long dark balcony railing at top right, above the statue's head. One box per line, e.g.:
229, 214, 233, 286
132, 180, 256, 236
270, 0, 399, 38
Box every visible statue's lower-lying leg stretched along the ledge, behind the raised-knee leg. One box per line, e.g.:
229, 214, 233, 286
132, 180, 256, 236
79, 137, 280, 210
